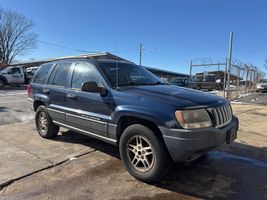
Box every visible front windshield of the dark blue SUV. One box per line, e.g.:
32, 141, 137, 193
98, 62, 164, 87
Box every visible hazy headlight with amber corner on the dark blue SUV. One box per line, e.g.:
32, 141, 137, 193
175, 109, 212, 129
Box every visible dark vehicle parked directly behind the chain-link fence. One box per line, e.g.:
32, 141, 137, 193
187, 75, 223, 91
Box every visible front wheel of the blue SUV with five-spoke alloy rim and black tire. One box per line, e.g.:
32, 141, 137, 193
119, 124, 171, 183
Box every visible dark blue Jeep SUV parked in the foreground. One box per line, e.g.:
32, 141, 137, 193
28, 58, 238, 182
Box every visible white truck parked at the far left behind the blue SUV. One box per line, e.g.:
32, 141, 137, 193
0, 66, 38, 89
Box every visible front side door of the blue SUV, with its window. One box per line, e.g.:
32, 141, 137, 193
66, 62, 110, 137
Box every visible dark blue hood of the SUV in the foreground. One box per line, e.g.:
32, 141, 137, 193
120, 85, 228, 108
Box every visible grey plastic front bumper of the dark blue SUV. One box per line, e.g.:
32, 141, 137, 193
160, 116, 239, 162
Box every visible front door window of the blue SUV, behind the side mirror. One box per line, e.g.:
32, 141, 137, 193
71, 63, 101, 89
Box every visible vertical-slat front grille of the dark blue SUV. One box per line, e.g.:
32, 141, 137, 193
211, 104, 233, 128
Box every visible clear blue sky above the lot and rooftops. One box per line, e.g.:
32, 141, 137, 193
0, 0, 267, 73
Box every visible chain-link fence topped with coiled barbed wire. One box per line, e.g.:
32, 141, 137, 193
189, 58, 265, 100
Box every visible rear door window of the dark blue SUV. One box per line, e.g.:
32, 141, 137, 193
52, 63, 71, 86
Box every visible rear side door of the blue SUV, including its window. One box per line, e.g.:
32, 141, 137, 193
43, 63, 71, 123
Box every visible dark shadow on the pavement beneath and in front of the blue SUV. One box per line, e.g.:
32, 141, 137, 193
54, 131, 267, 199
